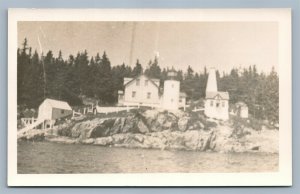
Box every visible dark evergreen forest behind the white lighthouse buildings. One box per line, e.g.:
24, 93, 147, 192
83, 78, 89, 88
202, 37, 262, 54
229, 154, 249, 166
17, 39, 279, 122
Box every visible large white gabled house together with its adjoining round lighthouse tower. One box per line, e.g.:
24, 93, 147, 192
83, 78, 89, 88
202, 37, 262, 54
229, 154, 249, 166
118, 72, 186, 110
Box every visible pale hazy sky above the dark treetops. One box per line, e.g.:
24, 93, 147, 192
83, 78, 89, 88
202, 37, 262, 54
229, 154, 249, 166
18, 21, 278, 72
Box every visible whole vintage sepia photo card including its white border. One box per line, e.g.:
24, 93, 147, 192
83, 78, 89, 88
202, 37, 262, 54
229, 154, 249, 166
8, 9, 292, 186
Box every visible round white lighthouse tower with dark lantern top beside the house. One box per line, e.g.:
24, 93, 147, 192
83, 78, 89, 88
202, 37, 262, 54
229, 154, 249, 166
162, 71, 180, 110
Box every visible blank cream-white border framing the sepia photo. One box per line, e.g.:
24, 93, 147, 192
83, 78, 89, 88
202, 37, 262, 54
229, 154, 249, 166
7, 9, 292, 186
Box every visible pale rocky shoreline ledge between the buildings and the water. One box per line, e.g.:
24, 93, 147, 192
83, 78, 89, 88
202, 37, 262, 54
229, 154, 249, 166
18, 110, 279, 153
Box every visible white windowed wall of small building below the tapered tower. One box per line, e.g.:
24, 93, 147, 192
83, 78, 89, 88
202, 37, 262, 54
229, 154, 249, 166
204, 99, 229, 120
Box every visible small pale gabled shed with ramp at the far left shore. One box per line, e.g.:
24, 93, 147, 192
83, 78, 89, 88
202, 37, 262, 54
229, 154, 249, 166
38, 98, 73, 120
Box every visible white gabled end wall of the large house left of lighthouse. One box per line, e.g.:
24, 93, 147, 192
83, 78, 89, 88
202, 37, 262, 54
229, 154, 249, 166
123, 76, 160, 107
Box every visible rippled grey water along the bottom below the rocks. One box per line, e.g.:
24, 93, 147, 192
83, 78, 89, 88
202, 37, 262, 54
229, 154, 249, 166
18, 142, 278, 174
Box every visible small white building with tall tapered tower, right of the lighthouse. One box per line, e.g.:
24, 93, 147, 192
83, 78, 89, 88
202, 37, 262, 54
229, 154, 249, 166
204, 68, 229, 120
